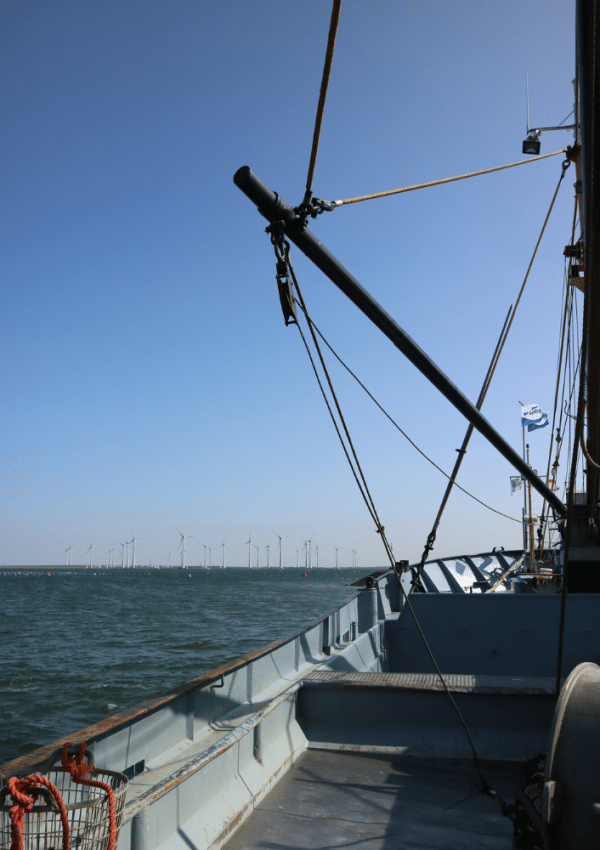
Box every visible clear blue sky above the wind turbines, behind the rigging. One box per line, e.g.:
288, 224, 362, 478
0, 0, 575, 567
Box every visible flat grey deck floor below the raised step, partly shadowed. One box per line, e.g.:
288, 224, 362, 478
225, 750, 523, 850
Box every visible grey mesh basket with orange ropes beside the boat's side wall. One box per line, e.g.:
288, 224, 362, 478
0, 753, 127, 850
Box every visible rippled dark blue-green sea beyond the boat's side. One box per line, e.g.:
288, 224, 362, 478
0, 568, 370, 764
